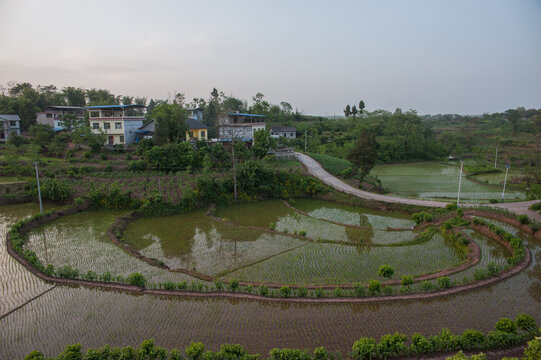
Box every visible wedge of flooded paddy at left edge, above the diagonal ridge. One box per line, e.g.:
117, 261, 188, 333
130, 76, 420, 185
0, 204, 52, 316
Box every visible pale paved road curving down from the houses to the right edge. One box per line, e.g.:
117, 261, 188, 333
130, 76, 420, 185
296, 153, 541, 222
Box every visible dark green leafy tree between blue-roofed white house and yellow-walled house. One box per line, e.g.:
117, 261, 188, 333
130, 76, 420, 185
152, 104, 188, 145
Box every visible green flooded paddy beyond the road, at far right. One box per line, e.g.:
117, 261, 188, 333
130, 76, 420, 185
370, 162, 525, 203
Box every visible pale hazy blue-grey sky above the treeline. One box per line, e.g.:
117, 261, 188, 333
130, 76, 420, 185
0, 0, 541, 115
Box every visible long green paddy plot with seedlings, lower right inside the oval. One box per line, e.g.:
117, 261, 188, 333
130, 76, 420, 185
227, 235, 462, 284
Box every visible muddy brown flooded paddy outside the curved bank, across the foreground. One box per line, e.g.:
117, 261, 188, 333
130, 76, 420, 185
0, 205, 541, 359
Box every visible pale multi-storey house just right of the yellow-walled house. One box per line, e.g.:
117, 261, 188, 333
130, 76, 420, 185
218, 113, 266, 144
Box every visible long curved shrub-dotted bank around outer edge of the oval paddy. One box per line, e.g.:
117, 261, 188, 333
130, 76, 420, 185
6, 206, 531, 303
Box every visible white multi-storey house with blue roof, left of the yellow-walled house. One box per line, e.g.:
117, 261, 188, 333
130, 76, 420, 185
87, 105, 146, 146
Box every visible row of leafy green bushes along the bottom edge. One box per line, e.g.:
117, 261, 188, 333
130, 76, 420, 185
25, 320, 541, 360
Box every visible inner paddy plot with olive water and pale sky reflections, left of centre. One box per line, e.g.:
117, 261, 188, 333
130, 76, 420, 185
123, 210, 305, 275
